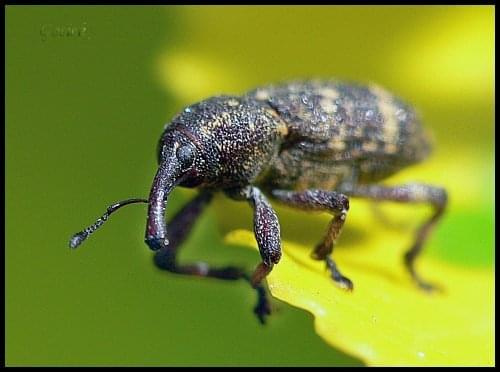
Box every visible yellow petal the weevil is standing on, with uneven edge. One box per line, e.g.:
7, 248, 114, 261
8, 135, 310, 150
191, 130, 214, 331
226, 230, 494, 366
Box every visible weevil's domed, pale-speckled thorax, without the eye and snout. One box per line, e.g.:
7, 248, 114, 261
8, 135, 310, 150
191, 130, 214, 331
164, 96, 286, 189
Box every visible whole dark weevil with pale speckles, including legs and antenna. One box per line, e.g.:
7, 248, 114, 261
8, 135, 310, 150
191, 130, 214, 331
69, 80, 447, 323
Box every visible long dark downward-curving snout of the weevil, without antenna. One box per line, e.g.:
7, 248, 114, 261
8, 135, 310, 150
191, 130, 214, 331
145, 158, 181, 251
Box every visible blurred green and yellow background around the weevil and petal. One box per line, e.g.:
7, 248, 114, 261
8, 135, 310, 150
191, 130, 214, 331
5, 6, 494, 365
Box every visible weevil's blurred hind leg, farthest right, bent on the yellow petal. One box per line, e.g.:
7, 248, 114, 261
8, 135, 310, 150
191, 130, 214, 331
340, 183, 448, 291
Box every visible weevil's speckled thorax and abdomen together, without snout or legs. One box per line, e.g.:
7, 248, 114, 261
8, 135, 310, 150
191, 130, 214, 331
159, 81, 430, 190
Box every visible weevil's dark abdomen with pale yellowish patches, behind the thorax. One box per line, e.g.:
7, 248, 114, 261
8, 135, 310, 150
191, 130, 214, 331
248, 80, 430, 189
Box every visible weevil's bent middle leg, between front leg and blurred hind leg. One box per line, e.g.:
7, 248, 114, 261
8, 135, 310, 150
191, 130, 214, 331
271, 190, 353, 290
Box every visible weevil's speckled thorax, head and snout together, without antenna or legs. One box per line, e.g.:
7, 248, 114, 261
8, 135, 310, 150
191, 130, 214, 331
146, 96, 285, 249
